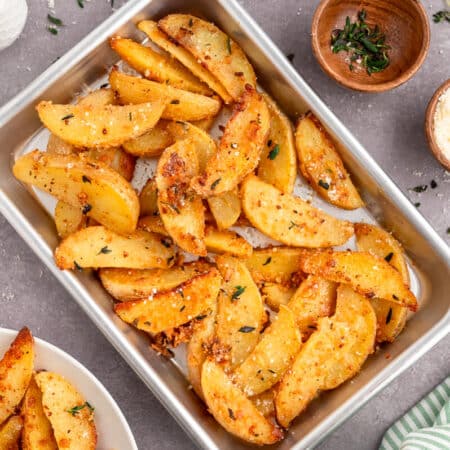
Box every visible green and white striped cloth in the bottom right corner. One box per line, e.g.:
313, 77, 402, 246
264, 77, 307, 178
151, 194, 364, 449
380, 377, 450, 450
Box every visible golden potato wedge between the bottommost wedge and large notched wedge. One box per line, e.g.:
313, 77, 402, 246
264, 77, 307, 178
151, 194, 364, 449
234, 305, 302, 396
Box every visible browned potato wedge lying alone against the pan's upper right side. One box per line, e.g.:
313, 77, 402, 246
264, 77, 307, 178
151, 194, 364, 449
295, 113, 364, 209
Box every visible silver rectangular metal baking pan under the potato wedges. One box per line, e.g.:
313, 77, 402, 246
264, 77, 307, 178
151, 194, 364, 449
0, 0, 450, 449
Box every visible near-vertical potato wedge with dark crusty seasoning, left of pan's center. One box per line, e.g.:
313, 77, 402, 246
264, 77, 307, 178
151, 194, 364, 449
156, 139, 206, 256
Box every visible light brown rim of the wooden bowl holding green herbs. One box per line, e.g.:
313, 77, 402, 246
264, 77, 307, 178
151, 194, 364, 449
311, 0, 430, 93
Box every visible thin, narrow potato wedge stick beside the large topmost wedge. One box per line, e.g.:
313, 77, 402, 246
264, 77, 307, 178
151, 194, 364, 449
138, 20, 233, 103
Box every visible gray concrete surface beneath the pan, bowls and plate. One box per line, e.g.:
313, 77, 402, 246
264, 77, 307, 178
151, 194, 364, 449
0, 0, 450, 450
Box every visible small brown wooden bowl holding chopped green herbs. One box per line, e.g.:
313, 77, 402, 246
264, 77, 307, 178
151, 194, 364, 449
312, 0, 430, 92
